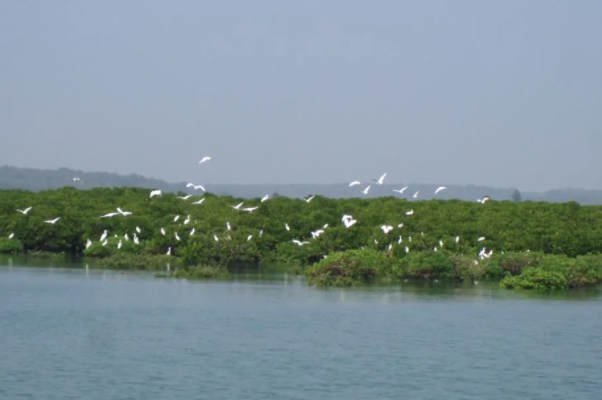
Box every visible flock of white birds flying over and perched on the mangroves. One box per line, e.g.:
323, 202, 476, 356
8, 156, 493, 264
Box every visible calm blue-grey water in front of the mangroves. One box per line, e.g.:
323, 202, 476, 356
0, 265, 602, 400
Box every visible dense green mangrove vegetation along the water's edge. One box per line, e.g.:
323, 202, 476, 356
0, 187, 602, 289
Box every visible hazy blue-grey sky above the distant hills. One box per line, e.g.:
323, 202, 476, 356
0, 0, 602, 190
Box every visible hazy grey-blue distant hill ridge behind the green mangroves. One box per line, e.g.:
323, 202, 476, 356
0, 166, 602, 205
